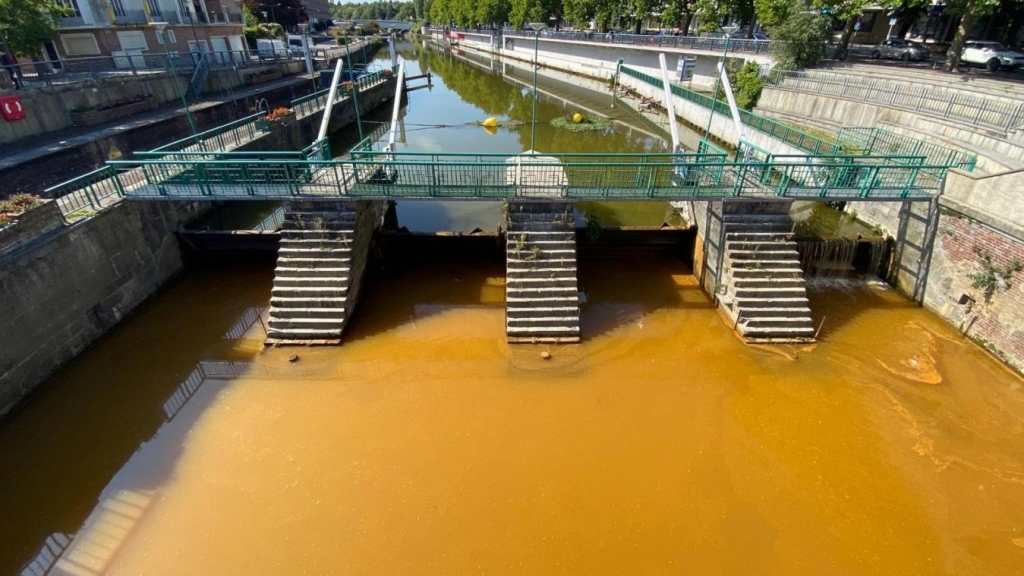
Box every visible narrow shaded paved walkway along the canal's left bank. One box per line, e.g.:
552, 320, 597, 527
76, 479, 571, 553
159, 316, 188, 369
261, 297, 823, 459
0, 73, 313, 170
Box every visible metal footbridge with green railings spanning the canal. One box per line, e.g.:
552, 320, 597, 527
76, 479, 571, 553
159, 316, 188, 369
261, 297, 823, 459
49, 54, 970, 213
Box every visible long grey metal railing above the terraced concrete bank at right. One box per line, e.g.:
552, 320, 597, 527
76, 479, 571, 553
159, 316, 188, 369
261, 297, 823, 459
765, 70, 1024, 132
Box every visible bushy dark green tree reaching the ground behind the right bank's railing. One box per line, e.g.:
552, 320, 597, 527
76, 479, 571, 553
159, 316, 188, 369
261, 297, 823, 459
768, 0, 831, 70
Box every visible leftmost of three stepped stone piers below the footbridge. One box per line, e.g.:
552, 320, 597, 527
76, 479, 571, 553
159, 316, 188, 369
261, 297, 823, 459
266, 206, 356, 344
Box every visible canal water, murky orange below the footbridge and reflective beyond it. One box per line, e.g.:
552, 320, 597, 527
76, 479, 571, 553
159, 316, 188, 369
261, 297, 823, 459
0, 41, 1024, 574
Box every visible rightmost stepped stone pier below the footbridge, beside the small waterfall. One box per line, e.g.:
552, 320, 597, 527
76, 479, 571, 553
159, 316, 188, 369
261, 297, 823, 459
719, 203, 814, 342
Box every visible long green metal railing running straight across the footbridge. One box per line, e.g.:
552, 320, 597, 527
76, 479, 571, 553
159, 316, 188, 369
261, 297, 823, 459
96, 147, 941, 200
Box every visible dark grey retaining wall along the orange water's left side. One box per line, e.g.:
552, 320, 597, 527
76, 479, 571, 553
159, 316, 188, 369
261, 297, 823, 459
0, 202, 203, 415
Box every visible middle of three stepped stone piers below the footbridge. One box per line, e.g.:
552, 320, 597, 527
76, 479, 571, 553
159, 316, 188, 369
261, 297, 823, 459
505, 202, 580, 343
